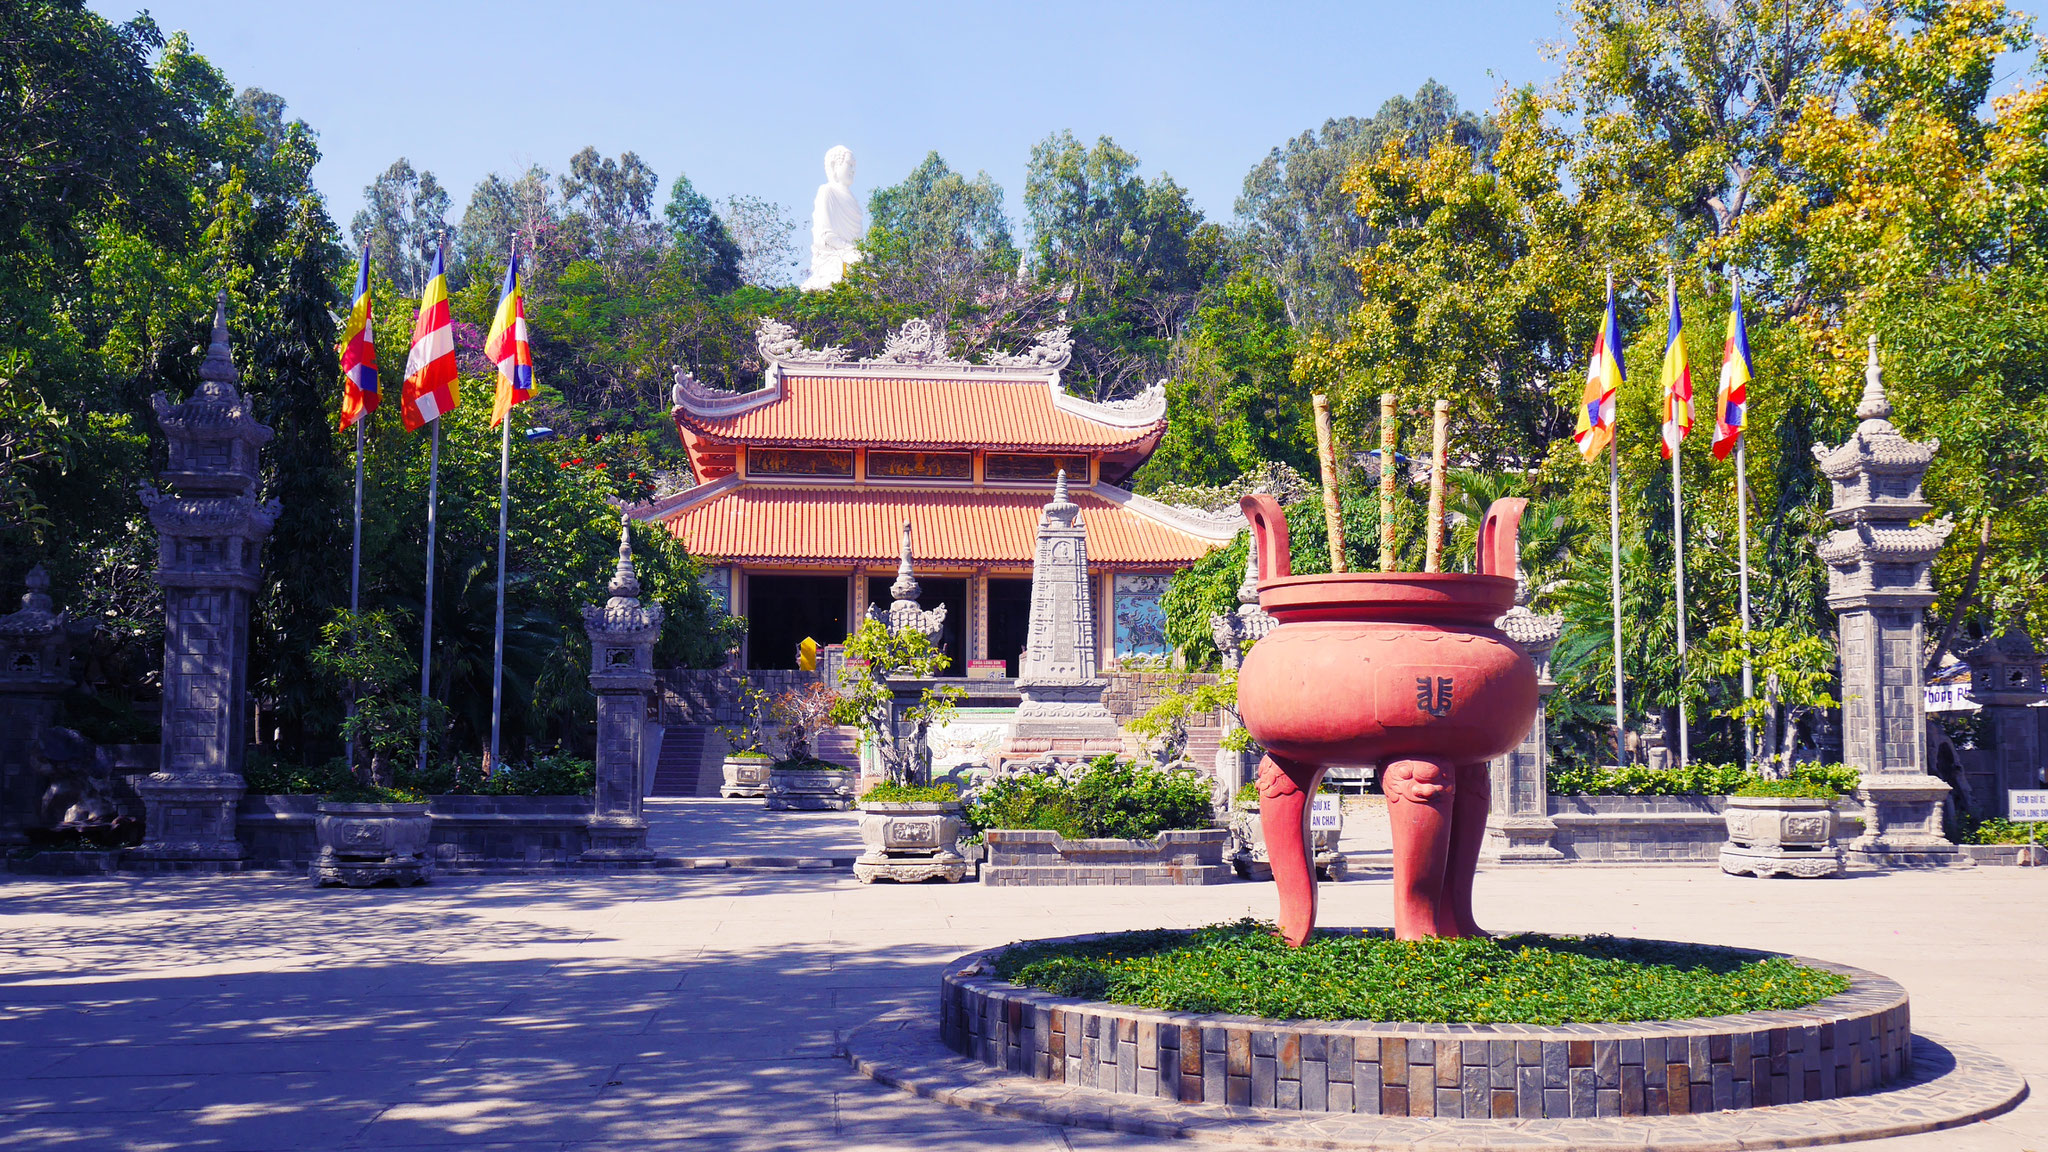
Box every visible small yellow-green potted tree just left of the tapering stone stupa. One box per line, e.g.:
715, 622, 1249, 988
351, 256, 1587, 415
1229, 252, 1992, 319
829, 619, 967, 785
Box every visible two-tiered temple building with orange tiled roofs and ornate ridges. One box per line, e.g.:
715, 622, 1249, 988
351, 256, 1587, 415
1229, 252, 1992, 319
635, 320, 1243, 676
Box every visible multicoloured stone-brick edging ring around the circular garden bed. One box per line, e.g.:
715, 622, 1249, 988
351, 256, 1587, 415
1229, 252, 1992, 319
940, 937, 1913, 1119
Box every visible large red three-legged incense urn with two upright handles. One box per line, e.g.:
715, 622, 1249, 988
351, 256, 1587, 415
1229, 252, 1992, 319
1237, 496, 1536, 947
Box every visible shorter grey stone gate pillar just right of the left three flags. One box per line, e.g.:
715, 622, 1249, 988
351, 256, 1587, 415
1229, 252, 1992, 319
584, 517, 662, 861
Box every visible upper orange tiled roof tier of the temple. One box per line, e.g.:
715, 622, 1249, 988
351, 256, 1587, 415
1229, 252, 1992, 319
678, 373, 1165, 451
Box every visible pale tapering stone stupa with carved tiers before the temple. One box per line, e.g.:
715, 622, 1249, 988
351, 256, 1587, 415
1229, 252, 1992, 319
1001, 471, 1124, 763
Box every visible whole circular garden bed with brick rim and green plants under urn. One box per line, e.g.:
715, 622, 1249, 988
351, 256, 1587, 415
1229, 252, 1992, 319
940, 922, 1913, 1119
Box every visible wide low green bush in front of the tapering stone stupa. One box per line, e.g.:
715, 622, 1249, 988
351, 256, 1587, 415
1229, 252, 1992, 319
967, 756, 1214, 840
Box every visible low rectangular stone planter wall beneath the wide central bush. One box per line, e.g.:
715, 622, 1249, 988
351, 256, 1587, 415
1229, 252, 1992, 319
981, 828, 1235, 886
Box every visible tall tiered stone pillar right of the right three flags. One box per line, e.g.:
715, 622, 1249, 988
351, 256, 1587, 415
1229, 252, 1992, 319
1812, 336, 1968, 867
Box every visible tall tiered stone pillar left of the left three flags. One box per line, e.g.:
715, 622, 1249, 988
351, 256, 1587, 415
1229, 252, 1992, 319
129, 291, 279, 869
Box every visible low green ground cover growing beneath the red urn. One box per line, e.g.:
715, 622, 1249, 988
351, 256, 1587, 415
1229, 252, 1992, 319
995, 920, 1849, 1025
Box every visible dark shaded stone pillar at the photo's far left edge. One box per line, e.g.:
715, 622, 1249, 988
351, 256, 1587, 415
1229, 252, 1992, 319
0, 564, 74, 845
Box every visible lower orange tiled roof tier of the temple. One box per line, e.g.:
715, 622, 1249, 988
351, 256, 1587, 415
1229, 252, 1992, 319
657, 479, 1223, 566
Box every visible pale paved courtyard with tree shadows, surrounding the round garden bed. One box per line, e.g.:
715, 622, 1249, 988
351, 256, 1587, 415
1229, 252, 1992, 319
0, 806, 2048, 1152
